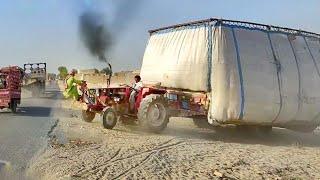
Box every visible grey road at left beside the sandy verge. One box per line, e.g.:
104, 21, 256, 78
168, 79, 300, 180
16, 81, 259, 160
0, 85, 62, 179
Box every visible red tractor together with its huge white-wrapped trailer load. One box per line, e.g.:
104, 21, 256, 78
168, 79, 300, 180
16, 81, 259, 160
84, 18, 320, 132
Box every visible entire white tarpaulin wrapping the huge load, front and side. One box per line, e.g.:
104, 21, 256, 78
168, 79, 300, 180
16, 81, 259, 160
141, 21, 320, 125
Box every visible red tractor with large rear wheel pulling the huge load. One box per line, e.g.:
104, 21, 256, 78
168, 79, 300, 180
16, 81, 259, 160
80, 81, 207, 133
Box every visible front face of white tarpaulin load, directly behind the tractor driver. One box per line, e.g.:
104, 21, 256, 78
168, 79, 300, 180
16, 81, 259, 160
141, 26, 208, 91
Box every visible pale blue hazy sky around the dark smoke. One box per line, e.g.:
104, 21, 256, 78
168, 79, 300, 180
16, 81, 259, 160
0, 0, 320, 72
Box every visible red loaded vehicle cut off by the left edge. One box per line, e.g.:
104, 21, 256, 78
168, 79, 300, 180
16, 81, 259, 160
0, 66, 23, 113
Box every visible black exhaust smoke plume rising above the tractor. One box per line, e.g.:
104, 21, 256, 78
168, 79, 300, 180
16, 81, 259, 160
79, 0, 143, 62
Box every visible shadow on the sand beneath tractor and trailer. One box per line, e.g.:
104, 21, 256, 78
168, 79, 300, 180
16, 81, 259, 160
117, 119, 320, 147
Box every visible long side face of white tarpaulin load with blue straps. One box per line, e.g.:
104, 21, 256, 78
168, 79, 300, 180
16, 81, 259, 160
209, 26, 320, 124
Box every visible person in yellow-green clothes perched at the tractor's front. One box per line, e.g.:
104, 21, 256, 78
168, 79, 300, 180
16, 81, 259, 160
63, 70, 82, 101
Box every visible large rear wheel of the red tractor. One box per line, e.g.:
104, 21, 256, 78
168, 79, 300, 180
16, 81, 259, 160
138, 94, 169, 133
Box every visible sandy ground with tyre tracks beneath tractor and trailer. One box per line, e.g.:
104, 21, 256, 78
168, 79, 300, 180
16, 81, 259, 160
28, 97, 320, 179
